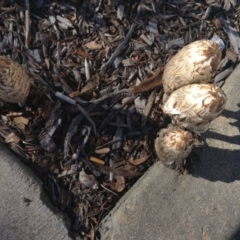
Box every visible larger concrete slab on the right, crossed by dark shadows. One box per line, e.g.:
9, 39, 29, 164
100, 65, 240, 240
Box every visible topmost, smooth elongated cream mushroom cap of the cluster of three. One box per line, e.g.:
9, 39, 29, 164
162, 40, 222, 95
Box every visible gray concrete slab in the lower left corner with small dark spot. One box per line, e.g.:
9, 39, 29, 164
0, 144, 70, 240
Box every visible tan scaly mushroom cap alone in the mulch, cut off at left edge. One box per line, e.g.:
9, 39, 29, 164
0, 56, 30, 104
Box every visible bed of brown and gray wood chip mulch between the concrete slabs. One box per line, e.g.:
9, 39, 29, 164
0, 0, 240, 239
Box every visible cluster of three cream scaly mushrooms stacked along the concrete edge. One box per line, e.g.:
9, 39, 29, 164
155, 40, 226, 166
